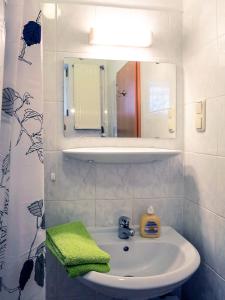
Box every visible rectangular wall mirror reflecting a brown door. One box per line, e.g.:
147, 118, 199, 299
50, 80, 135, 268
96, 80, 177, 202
64, 58, 176, 139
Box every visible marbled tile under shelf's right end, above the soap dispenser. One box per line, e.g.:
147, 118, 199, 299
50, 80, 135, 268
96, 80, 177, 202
131, 156, 183, 198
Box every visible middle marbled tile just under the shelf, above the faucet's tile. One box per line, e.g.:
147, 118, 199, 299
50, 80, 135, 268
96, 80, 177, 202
96, 164, 133, 199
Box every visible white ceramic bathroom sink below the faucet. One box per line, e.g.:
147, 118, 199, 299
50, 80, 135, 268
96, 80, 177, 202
79, 227, 200, 300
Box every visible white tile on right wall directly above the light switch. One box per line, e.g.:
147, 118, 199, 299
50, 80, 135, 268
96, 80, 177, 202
184, 39, 225, 103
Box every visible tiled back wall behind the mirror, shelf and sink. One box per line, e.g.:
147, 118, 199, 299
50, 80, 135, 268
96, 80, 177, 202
43, 1, 183, 300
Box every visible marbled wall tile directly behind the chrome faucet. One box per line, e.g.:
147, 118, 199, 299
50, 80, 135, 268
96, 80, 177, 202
96, 199, 132, 226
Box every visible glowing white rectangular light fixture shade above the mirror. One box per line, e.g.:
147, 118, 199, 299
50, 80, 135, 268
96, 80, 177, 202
89, 28, 152, 48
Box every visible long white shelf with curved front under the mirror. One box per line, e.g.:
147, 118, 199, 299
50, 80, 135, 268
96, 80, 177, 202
63, 147, 181, 163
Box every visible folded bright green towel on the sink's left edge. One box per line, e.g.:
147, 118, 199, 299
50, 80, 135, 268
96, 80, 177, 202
46, 222, 110, 277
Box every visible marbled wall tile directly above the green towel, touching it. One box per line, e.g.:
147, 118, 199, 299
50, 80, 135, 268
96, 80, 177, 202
45, 200, 95, 227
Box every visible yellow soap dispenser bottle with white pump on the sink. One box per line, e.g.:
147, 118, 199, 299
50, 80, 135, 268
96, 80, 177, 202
140, 206, 160, 238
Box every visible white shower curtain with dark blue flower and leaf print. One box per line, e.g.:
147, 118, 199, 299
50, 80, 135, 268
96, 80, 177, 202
0, 0, 45, 300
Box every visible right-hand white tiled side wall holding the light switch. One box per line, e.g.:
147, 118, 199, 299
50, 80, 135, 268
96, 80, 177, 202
183, 0, 225, 300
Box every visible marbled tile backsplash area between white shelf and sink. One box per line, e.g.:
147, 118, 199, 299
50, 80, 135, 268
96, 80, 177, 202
45, 151, 183, 231
